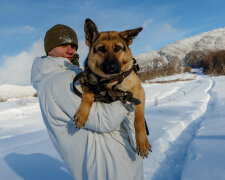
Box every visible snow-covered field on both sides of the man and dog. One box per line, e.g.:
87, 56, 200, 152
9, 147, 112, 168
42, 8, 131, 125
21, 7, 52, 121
0, 74, 225, 180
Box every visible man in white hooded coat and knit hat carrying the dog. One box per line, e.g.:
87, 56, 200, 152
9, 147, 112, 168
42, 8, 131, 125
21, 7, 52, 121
31, 25, 143, 180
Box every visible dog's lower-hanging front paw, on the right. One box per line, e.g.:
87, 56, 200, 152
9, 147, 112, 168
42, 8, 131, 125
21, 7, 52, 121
136, 134, 152, 158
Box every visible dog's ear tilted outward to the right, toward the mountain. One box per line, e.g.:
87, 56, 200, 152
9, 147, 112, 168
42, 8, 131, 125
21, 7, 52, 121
120, 27, 143, 46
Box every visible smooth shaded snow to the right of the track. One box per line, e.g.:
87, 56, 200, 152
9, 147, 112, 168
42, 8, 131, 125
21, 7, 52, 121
182, 77, 225, 180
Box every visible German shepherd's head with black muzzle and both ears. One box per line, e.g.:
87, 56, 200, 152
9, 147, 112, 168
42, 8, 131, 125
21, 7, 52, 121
84, 19, 143, 78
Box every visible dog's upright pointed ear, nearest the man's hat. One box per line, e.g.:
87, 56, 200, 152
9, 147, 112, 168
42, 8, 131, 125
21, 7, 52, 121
84, 19, 99, 47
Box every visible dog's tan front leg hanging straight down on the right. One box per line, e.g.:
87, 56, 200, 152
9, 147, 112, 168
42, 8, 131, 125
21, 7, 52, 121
133, 85, 151, 158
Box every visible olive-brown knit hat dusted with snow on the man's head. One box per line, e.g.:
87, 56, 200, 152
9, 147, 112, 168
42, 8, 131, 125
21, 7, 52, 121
44, 24, 78, 54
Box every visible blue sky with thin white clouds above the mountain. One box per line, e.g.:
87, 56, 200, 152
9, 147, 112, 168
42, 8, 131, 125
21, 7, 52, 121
0, 0, 225, 83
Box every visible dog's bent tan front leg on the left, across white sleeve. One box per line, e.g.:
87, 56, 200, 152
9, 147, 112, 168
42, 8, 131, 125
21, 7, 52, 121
74, 86, 94, 128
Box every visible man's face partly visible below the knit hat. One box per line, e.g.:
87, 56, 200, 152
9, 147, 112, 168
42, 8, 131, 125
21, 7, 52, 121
48, 44, 77, 60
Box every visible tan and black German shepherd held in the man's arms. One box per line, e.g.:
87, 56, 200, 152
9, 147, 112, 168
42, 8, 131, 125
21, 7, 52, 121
74, 19, 151, 158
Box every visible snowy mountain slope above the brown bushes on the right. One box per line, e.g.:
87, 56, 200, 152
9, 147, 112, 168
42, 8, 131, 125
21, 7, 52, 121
135, 28, 225, 69
